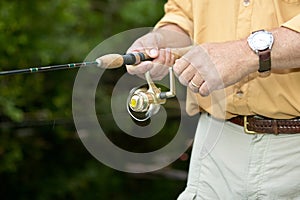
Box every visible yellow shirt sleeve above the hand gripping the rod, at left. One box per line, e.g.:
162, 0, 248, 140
155, 0, 193, 37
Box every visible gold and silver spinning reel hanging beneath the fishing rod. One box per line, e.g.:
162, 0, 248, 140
126, 67, 176, 122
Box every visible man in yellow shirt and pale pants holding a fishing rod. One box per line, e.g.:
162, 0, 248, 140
127, 0, 300, 200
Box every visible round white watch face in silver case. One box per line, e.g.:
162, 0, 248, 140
248, 31, 273, 51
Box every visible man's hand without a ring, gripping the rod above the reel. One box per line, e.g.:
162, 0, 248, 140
126, 25, 191, 80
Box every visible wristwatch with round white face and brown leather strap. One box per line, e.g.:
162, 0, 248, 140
247, 30, 274, 76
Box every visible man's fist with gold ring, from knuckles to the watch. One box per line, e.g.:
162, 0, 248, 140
173, 40, 258, 96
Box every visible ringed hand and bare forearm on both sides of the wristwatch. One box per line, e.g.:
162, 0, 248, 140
173, 27, 300, 96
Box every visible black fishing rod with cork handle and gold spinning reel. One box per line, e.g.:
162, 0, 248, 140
0, 46, 191, 121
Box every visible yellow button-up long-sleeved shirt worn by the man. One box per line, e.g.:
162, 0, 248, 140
156, 0, 300, 119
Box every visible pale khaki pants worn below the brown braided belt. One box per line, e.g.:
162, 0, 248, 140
178, 114, 300, 200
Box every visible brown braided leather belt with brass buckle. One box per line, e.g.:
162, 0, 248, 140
228, 116, 300, 134
